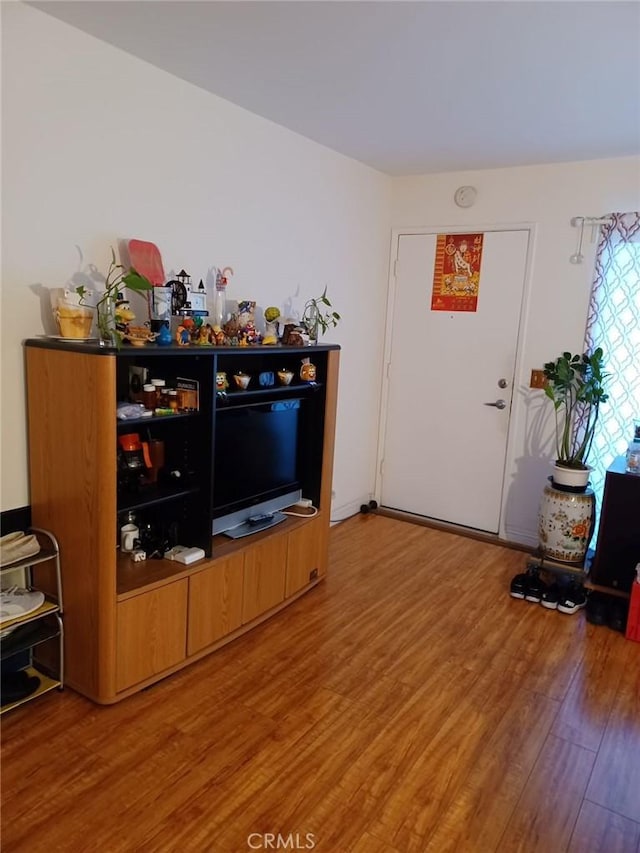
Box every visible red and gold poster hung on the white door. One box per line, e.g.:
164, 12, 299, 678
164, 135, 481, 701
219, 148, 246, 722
431, 234, 484, 311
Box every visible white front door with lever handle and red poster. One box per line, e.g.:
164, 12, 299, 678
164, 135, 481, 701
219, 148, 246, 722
380, 229, 529, 533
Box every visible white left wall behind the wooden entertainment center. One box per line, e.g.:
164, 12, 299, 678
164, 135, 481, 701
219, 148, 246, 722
1, 3, 391, 517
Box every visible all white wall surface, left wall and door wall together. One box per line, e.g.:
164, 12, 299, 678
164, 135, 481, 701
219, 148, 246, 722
0, 3, 640, 543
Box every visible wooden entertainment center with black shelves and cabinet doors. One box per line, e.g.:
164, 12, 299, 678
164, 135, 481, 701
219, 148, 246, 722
25, 338, 340, 704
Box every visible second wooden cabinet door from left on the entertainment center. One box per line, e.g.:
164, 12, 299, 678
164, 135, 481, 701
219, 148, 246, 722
187, 553, 244, 655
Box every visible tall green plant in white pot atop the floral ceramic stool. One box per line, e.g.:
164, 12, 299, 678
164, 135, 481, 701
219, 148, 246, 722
544, 347, 608, 488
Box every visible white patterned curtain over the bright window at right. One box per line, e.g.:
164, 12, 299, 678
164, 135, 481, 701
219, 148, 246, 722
585, 213, 640, 536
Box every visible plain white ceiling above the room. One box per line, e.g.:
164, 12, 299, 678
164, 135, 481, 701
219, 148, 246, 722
31, 0, 640, 175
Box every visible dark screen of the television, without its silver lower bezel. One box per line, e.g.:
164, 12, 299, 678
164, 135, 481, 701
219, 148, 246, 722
213, 400, 300, 516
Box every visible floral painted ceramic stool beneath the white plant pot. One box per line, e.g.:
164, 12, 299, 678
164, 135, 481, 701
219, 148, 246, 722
538, 485, 596, 564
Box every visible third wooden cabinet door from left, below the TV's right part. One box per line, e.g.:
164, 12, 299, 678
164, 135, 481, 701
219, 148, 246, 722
242, 535, 288, 623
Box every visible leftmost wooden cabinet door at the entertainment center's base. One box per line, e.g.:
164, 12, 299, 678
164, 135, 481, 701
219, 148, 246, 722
116, 578, 188, 691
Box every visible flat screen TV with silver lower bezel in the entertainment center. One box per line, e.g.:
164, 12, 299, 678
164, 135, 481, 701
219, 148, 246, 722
212, 399, 302, 539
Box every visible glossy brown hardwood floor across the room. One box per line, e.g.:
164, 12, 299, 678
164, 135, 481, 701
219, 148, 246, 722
2, 514, 640, 853
